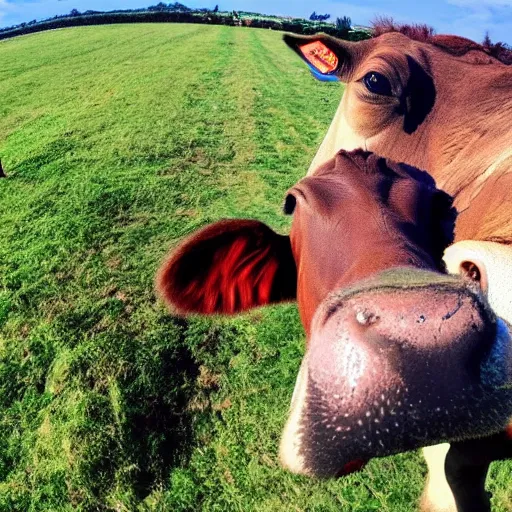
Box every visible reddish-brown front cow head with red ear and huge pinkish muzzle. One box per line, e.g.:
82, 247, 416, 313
157, 151, 512, 503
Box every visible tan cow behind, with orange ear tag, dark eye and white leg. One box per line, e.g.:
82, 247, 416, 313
285, 26, 512, 511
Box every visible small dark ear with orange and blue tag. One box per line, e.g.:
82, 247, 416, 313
283, 34, 354, 81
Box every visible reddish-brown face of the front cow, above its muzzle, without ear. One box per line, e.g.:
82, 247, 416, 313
284, 151, 456, 332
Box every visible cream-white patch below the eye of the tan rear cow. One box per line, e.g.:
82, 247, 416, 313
308, 91, 366, 176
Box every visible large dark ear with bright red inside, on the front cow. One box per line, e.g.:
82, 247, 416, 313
156, 220, 297, 314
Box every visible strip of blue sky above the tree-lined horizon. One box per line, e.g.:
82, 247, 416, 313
0, 0, 512, 44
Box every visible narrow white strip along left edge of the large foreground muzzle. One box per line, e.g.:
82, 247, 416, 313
279, 357, 308, 474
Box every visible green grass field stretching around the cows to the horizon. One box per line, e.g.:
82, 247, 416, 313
0, 24, 512, 512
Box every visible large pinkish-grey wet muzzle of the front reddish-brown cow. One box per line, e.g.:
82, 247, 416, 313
281, 269, 512, 476
